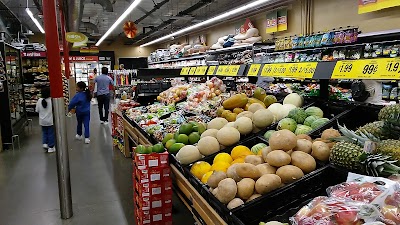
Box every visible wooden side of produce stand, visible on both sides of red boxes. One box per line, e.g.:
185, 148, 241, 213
123, 117, 227, 225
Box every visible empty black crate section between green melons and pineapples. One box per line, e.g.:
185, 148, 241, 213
311, 104, 382, 138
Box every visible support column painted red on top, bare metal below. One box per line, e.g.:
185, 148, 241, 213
43, 0, 73, 219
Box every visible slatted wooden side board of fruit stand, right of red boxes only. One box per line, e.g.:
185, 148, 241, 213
170, 164, 227, 225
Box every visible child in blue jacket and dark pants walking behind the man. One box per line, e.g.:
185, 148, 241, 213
68, 81, 92, 144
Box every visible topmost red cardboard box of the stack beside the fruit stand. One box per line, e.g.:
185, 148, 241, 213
132, 148, 169, 170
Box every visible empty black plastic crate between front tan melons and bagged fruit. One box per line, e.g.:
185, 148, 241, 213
232, 165, 347, 225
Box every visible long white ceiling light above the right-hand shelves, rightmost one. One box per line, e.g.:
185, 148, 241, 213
140, 0, 270, 47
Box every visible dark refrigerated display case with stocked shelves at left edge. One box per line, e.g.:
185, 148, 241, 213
0, 42, 28, 147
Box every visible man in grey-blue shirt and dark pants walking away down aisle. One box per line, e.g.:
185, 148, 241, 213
94, 67, 113, 124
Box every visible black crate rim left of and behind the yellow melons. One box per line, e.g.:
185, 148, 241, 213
183, 137, 266, 224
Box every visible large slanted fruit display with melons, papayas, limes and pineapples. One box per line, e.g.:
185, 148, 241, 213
124, 78, 400, 225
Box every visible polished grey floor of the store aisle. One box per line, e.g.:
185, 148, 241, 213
0, 107, 194, 225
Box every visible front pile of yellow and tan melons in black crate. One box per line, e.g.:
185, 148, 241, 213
191, 130, 330, 209
